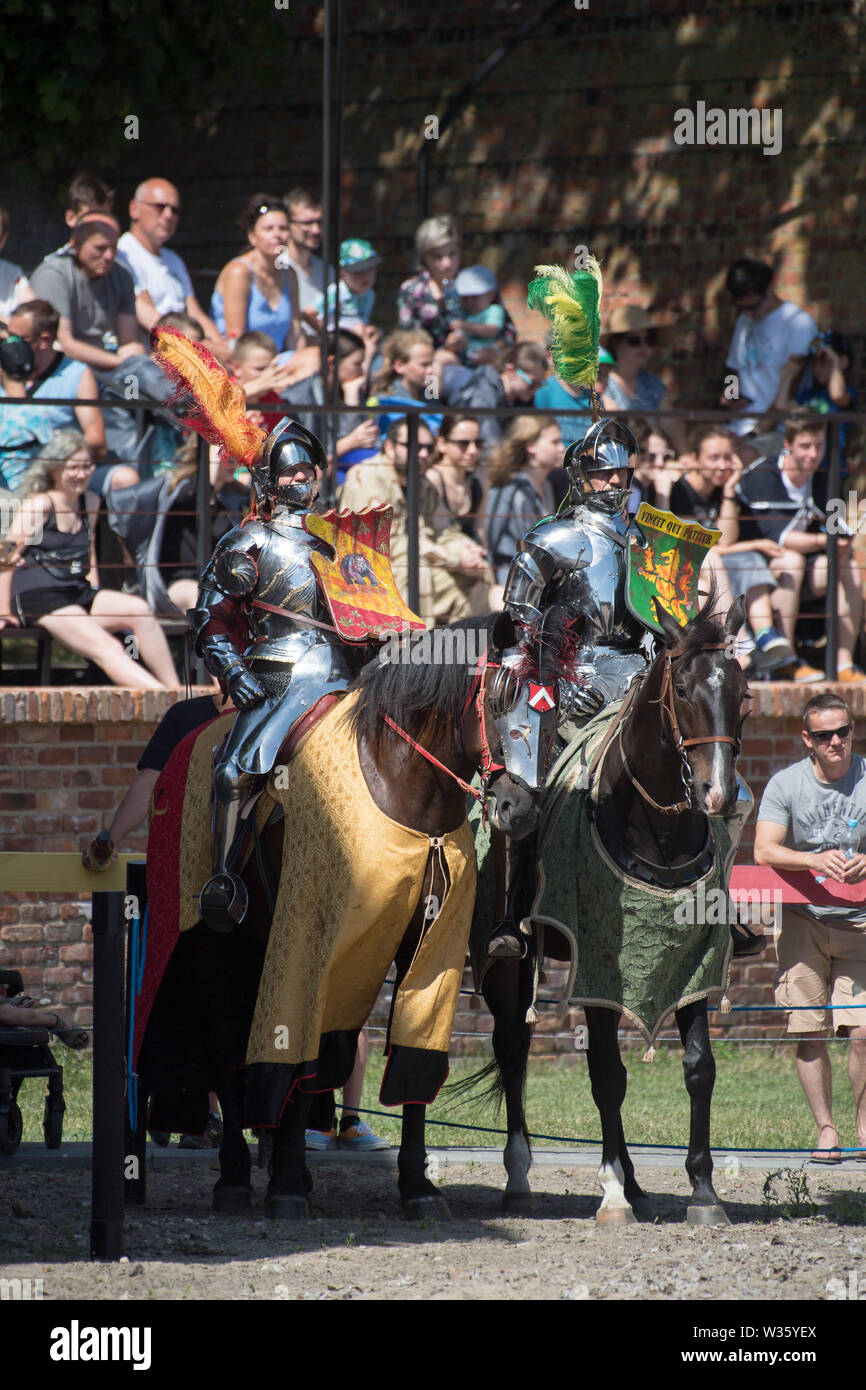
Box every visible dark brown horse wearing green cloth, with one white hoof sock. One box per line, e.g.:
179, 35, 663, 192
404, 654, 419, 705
482, 599, 748, 1225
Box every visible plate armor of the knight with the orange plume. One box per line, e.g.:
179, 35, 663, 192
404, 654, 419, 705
190, 420, 357, 930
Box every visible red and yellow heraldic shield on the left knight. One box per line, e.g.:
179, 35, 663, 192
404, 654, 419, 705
303, 505, 427, 642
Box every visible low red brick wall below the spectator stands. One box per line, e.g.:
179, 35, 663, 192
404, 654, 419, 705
0, 682, 866, 1054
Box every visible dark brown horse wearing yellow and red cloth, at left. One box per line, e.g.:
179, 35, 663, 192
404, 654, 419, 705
140, 614, 555, 1219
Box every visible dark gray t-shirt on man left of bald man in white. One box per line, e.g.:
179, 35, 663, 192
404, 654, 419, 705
31, 247, 135, 352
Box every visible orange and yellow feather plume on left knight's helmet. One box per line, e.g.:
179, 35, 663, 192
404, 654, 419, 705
150, 328, 267, 468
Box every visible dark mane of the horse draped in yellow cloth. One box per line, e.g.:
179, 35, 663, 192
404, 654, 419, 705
349, 614, 496, 746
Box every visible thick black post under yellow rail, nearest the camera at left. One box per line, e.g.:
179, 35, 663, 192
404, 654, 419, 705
90, 892, 126, 1259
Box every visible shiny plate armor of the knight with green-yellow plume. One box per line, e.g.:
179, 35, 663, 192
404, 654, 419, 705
503, 420, 648, 723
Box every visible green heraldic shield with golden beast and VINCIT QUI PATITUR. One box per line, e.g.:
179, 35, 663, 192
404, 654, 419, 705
626, 502, 721, 635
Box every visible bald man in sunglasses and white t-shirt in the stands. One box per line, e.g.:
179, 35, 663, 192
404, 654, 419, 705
117, 178, 225, 350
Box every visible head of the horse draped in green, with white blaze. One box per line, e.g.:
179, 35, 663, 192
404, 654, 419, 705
652, 595, 748, 816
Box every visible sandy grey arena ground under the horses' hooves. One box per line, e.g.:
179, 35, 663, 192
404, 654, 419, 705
0, 1154, 866, 1301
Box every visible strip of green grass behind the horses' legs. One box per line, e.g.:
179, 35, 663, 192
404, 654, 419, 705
19, 1043, 856, 1151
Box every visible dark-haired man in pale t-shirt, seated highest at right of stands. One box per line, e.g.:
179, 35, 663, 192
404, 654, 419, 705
720, 259, 817, 461
